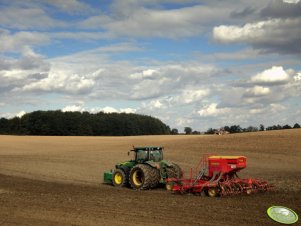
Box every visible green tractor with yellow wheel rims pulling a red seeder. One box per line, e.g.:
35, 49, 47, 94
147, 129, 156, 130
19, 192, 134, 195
104, 147, 182, 190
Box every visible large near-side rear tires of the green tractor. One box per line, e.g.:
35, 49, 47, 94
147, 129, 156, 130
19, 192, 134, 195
130, 164, 160, 190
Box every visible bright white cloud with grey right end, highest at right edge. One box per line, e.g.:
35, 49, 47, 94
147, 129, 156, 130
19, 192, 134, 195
213, 18, 301, 54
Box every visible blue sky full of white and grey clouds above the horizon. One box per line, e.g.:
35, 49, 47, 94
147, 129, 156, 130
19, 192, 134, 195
0, 0, 301, 131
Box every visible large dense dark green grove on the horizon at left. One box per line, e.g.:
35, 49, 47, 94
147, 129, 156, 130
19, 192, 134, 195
0, 110, 170, 136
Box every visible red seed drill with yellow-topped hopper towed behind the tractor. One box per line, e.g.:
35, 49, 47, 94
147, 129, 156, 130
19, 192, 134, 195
167, 155, 273, 197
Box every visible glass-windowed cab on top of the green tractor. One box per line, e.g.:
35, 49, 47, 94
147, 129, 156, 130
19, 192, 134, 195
131, 147, 163, 163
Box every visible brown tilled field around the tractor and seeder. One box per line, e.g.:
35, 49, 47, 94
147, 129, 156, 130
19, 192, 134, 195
0, 129, 301, 225
